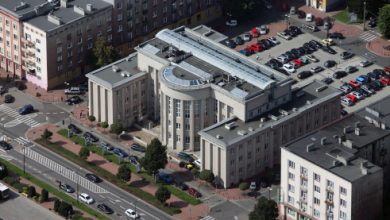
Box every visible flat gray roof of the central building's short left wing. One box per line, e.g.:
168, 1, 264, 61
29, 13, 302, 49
86, 53, 146, 89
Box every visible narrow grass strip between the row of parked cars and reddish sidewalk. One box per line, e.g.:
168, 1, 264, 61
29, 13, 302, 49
57, 129, 202, 205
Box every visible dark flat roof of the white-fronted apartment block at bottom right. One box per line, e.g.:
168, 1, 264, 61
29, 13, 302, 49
281, 130, 383, 182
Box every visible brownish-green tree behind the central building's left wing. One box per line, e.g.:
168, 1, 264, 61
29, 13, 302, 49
87, 36, 120, 70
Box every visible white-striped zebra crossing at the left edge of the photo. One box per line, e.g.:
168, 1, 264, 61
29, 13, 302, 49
0, 104, 40, 128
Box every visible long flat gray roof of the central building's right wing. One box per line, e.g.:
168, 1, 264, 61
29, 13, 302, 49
199, 80, 340, 147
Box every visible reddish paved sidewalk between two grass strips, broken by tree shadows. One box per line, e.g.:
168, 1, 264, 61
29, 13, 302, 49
27, 124, 207, 220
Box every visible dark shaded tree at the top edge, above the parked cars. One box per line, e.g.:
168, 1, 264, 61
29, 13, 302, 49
226, 0, 257, 19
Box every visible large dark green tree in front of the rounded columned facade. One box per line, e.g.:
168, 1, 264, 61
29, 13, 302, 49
139, 138, 168, 175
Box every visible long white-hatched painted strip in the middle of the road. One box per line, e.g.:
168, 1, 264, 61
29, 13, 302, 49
15, 148, 108, 193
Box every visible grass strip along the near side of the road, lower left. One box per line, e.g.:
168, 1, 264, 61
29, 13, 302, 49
0, 158, 110, 220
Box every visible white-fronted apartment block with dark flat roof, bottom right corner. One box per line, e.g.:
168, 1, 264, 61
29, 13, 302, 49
279, 127, 387, 220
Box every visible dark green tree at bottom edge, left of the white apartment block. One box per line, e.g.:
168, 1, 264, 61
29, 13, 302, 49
249, 196, 279, 220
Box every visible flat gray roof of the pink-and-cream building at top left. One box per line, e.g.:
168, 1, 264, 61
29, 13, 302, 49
26, 0, 111, 31
